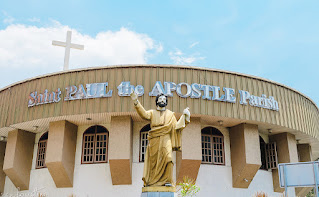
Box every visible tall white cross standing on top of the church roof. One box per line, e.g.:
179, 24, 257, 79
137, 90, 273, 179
52, 31, 84, 70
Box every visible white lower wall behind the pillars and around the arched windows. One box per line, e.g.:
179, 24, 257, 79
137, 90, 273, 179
4, 122, 295, 197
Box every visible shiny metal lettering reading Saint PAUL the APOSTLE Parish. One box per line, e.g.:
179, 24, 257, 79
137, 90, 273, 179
28, 81, 279, 111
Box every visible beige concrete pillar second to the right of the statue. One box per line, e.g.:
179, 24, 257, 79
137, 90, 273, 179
230, 124, 261, 188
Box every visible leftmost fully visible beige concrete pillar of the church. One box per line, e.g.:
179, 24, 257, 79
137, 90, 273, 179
3, 129, 35, 190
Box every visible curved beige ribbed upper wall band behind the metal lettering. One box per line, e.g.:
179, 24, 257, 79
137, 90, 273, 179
0, 65, 319, 145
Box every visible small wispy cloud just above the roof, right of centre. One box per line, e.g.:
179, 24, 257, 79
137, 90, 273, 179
168, 49, 205, 65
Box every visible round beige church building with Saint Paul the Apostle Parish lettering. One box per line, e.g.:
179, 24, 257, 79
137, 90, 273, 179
0, 65, 319, 197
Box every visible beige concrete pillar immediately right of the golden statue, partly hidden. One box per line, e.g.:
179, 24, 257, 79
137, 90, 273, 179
176, 118, 202, 182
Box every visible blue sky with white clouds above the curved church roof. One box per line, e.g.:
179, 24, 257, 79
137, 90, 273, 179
0, 0, 319, 105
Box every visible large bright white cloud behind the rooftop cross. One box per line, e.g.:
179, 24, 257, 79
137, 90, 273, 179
0, 23, 163, 71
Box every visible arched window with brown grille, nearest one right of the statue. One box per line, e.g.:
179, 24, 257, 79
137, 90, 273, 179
202, 127, 225, 165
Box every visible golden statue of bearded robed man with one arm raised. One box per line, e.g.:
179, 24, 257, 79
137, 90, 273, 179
131, 91, 190, 187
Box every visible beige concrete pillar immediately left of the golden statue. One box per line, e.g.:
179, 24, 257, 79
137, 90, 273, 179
109, 116, 133, 185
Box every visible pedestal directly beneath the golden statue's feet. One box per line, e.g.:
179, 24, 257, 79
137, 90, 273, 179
141, 186, 176, 197
